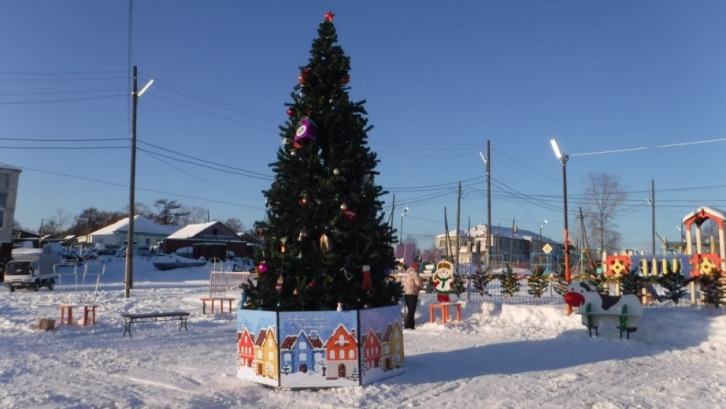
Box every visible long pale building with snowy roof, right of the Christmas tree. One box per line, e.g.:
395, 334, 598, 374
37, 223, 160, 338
436, 224, 563, 264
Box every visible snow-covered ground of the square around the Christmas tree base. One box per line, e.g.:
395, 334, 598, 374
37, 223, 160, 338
0, 257, 726, 409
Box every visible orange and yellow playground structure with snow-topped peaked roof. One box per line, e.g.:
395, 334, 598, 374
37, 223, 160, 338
602, 206, 726, 304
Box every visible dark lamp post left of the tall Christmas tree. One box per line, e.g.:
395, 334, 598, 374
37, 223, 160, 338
124, 66, 154, 298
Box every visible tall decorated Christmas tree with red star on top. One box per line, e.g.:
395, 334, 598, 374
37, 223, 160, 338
246, 13, 402, 311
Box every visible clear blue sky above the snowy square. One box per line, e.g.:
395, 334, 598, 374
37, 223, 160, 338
0, 0, 726, 250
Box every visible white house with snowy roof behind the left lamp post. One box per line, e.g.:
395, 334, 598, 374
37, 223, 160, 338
90, 215, 179, 246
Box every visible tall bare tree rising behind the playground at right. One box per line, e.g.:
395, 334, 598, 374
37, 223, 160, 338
584, 172, 628, 252
